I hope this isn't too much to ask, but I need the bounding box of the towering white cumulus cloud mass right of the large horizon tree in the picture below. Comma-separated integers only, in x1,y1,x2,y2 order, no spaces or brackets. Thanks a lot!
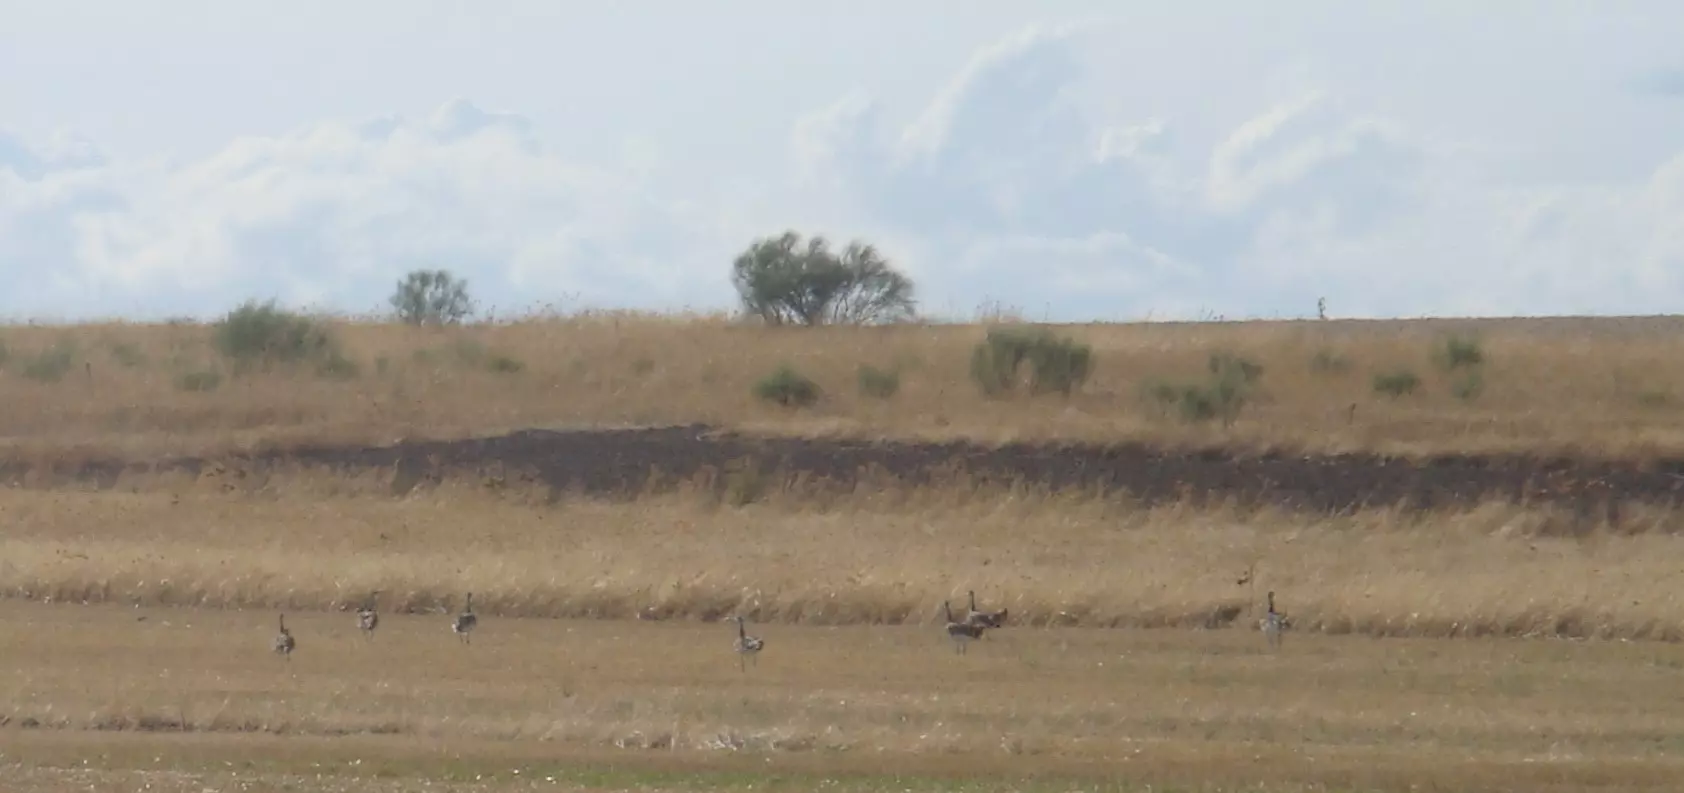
781,27,1684,318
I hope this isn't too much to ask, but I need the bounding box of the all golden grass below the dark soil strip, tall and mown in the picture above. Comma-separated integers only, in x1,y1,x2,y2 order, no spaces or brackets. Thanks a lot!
0,471,1684,793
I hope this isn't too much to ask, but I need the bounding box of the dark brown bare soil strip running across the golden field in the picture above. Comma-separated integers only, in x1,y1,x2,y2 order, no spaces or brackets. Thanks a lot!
0,426,1684,524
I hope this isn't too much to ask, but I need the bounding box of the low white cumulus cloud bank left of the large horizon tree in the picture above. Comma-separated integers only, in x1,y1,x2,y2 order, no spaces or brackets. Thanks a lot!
0,99,751,317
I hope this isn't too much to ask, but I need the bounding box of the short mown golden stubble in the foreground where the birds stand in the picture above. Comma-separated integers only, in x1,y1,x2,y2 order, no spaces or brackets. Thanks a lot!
0,603,1684,793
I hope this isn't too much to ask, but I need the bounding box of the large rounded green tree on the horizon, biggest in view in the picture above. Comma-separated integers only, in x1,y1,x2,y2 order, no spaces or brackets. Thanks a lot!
731,231,916,325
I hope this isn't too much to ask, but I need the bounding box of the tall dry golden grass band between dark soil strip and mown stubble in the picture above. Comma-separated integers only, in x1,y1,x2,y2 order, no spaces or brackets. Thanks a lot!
0,473,1684,641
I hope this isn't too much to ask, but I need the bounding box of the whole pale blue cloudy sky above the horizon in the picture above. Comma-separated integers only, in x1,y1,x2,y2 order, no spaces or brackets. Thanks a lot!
0,0,1684,322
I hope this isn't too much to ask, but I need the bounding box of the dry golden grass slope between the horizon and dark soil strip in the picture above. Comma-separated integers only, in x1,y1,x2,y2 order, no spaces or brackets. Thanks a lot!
0,308,1684,456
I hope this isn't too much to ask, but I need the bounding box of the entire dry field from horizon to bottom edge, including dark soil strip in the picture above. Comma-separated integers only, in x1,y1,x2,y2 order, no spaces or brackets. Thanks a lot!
0,318,1684,793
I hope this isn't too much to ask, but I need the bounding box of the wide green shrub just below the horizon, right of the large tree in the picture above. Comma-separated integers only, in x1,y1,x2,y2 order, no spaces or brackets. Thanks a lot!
970,328,1093,397
